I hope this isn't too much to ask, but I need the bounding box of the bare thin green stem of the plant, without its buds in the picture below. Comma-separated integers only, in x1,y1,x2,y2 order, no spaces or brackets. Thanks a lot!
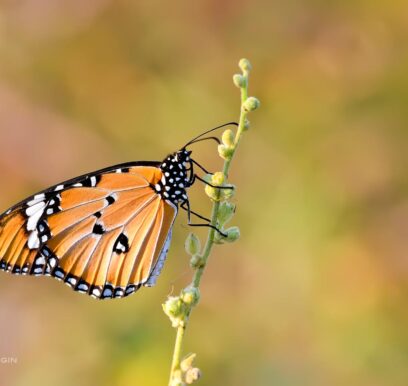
169,61,253,386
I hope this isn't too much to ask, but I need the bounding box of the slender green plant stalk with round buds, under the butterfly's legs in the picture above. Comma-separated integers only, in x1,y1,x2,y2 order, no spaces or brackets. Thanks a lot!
163,59,259,386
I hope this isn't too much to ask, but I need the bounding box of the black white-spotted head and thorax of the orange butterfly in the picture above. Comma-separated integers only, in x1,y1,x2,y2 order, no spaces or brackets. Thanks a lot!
154,149,191,205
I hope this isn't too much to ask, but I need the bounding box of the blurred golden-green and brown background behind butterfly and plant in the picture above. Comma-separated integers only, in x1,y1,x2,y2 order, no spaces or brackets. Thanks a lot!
0,0,408,386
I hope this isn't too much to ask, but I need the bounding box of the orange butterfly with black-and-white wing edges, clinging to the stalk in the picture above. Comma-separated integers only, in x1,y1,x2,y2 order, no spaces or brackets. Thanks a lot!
0,122,237,299
